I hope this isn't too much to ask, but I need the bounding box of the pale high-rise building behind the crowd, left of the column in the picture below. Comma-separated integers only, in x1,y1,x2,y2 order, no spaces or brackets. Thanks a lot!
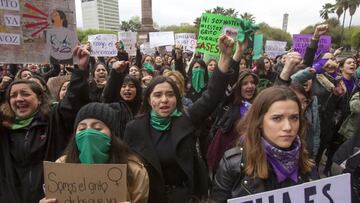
81,0,120,31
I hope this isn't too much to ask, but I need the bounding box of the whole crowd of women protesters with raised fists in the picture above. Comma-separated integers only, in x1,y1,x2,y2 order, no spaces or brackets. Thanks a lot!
0,22,360,203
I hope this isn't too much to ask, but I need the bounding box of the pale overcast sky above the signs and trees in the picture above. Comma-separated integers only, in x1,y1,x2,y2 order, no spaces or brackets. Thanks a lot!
75,0,360,34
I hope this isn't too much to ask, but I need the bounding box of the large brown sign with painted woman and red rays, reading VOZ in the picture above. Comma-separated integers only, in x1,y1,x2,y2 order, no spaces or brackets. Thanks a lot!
0,0,78,64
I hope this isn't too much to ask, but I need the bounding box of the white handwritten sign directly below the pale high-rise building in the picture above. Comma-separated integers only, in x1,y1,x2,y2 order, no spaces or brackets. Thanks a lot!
88,34,118,56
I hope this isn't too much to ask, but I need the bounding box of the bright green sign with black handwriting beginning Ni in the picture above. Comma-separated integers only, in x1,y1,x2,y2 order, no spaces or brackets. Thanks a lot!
196,13,240,55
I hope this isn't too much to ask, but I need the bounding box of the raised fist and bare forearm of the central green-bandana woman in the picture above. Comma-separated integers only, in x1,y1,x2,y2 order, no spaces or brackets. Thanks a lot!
218,35,234,73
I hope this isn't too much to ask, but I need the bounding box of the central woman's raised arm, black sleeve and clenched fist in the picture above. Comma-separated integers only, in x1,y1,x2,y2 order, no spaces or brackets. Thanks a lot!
188,35,234,125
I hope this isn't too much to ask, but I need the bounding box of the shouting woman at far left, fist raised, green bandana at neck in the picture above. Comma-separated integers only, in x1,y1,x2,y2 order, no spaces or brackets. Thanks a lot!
0,46,90,203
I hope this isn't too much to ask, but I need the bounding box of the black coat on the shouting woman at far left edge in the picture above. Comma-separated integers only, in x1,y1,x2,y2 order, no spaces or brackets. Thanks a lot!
0,69,89,203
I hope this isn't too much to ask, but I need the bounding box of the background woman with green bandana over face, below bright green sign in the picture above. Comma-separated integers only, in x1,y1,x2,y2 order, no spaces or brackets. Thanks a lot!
186,59,209,102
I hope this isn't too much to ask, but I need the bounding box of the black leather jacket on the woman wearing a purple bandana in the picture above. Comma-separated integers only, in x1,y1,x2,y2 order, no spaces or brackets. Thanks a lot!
210,147,319,202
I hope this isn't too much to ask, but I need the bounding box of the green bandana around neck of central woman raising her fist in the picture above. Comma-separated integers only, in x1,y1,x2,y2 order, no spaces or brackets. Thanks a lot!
150,109,182,131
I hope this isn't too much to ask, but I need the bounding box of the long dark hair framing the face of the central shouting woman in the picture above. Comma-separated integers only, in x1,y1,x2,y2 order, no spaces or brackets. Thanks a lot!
140,76,183,116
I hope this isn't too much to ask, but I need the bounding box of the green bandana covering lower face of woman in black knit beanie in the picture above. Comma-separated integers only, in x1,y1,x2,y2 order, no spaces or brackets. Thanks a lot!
75,128,111,164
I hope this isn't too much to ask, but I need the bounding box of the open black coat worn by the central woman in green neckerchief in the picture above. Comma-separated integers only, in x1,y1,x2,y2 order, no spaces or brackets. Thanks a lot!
124,70,231,203
